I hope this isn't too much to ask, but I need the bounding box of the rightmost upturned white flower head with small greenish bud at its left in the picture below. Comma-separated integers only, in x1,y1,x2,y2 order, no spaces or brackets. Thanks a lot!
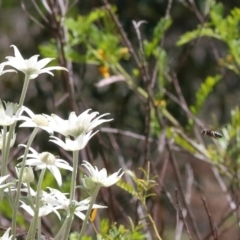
82,160,124,188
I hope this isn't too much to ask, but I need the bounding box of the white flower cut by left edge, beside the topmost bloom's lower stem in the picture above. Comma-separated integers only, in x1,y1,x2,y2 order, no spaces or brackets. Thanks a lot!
0,100,22,126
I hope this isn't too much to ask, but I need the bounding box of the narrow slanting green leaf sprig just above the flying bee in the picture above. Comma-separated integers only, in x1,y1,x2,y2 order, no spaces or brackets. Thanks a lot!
190,75,221,115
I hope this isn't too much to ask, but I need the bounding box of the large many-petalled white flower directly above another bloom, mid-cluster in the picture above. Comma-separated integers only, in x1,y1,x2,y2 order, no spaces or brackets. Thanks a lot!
47,109,112,138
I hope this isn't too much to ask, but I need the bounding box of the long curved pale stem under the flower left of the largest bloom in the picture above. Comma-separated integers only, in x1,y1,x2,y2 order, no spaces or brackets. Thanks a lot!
12,127,38,237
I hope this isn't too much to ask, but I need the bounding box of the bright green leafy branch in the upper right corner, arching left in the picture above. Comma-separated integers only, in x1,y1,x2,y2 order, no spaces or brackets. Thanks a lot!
177,3,240,75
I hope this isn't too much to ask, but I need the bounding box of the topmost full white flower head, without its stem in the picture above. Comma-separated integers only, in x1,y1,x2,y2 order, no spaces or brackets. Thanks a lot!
2,45,68,79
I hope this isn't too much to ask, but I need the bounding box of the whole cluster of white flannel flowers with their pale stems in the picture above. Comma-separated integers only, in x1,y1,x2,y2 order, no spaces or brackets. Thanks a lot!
0,45,124,239
